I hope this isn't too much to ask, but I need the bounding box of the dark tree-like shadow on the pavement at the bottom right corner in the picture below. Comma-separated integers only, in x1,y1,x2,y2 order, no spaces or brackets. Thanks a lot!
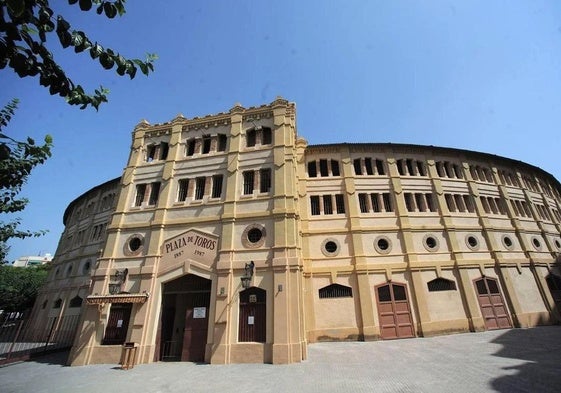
491,326,561,393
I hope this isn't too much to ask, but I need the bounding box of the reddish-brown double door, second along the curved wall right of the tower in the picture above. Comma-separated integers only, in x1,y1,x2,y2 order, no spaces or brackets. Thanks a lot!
474,277,512,330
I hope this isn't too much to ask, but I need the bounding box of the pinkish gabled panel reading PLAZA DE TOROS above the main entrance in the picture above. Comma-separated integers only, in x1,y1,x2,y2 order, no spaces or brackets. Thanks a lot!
162,230,218,266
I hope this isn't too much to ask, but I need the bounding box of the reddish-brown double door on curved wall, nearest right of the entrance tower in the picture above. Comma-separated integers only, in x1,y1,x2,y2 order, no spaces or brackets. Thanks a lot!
375,283,415,340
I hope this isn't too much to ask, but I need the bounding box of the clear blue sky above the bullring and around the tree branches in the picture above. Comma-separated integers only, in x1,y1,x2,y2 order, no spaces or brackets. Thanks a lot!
0,0,561,260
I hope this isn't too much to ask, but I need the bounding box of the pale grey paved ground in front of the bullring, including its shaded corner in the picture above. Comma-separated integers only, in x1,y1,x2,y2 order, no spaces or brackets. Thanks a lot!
0,326,561,393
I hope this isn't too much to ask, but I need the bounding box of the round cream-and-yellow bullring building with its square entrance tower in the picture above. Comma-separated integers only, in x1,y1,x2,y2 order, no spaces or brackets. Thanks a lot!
25,97,561,365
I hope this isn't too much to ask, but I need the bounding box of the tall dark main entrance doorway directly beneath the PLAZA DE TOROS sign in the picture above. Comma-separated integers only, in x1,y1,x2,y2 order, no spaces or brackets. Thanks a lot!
159,274,212,362
